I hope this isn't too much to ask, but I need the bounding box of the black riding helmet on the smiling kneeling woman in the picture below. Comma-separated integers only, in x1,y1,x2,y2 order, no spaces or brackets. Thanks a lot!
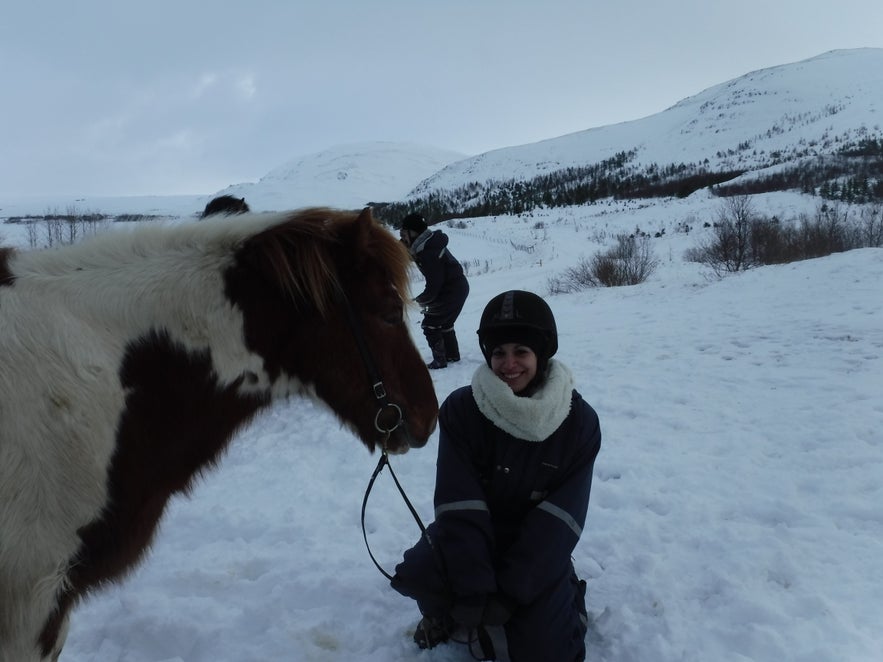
478,290,558,374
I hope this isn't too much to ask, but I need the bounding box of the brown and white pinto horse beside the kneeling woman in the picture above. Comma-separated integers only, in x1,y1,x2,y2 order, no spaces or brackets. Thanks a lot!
0,208,438,662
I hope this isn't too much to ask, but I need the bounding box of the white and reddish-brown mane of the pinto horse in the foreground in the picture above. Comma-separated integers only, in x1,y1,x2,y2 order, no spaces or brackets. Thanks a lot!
0,207,410,316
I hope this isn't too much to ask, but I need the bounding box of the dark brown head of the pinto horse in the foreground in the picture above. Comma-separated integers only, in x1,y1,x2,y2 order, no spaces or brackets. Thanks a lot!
227,209,438,452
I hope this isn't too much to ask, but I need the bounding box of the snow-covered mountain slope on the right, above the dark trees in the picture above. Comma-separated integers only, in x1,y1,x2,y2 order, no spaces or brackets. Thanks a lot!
412,48,883,196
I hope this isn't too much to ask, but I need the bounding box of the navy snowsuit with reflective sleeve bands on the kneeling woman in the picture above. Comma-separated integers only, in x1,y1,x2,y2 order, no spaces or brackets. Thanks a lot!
392,386,601,662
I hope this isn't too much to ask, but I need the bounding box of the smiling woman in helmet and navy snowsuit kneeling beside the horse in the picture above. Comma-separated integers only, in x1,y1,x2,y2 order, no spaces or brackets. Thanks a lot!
391,290,601,662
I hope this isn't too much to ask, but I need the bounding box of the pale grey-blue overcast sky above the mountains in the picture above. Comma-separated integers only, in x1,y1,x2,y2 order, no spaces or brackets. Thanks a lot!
0,0,883,197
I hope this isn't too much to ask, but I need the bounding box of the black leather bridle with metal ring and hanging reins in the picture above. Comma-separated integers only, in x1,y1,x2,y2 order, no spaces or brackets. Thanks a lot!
338,291,435,580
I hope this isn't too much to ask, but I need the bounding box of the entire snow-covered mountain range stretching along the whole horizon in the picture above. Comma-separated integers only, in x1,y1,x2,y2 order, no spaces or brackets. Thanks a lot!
0,48,883,223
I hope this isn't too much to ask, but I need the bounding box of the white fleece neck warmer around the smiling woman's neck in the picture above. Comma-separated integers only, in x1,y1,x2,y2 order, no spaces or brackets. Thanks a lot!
472,359,573,441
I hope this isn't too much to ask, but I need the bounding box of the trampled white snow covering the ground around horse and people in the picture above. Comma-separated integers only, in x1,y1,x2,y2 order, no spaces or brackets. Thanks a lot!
0,194,883,662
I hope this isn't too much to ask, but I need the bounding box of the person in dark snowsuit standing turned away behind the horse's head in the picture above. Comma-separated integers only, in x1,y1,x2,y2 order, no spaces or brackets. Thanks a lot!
399,214,469,370
